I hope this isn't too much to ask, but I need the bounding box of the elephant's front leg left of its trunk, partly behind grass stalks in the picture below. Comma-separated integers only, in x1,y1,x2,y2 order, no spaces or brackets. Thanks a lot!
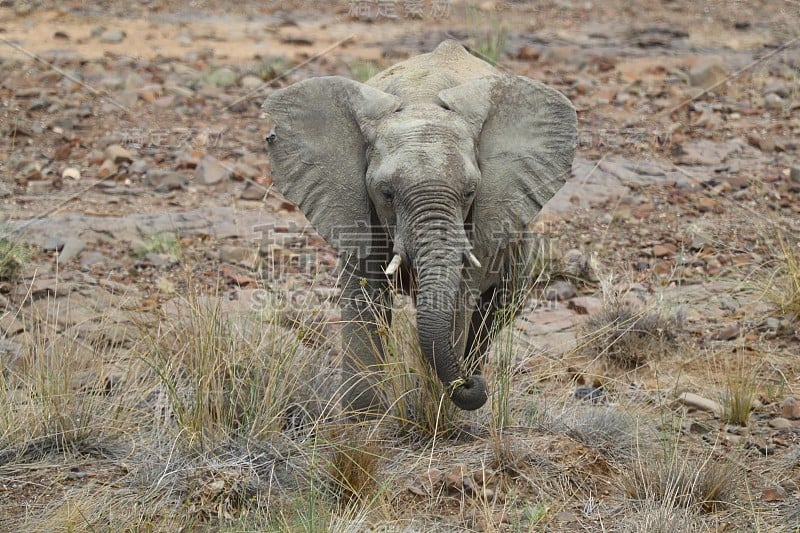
342,264,391,417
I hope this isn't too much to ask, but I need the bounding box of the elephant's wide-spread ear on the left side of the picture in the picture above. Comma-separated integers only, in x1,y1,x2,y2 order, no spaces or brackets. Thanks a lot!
263,76,400,246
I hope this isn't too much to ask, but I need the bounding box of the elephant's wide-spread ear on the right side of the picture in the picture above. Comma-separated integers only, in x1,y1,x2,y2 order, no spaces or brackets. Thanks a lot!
438,76,577,252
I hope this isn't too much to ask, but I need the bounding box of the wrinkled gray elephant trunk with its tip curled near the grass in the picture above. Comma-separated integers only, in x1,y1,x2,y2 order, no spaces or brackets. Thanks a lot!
413,214,487,411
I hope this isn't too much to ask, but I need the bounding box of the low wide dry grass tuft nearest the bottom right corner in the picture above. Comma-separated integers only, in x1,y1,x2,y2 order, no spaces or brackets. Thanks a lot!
620,445,740,512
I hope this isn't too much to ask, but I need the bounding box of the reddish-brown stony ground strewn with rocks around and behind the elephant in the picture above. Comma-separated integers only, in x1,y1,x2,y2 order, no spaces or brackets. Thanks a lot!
0,0,800,530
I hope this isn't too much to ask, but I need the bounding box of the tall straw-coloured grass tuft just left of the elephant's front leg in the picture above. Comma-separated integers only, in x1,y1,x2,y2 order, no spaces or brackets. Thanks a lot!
142,294,331,453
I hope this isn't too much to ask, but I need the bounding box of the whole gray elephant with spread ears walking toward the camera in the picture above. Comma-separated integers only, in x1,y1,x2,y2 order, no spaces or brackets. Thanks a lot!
264,41,577,414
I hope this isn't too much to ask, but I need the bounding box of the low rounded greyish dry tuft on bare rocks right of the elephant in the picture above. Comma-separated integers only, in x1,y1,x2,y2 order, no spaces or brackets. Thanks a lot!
581,298,678,368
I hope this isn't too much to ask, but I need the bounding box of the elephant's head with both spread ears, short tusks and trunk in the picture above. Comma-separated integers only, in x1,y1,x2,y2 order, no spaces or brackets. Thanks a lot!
264,40,576,409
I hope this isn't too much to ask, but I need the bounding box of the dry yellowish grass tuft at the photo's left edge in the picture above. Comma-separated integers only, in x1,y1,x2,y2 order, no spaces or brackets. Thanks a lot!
0,310,132,465
